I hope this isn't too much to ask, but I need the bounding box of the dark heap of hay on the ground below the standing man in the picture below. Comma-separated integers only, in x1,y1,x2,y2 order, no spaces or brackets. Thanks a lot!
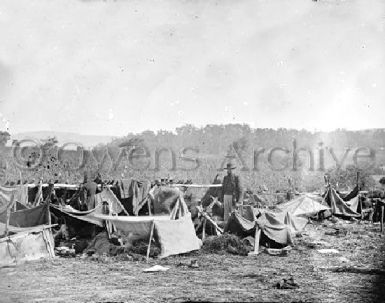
202,233,252,256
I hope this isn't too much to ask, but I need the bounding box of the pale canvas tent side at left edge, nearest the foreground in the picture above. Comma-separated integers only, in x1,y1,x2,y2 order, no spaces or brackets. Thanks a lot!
0,227,55,267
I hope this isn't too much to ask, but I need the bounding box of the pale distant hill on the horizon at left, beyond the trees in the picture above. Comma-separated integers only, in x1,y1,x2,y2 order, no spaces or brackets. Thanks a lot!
9,131,116,147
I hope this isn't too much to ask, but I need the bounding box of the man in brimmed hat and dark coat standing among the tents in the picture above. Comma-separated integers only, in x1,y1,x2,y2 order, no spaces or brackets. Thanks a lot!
222,163,243,223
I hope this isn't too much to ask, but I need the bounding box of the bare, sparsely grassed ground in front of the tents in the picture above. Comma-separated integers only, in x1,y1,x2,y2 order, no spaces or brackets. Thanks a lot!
0,222,385,302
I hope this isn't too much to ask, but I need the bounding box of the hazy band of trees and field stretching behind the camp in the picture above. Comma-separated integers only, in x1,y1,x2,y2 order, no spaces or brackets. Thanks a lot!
0,124,385,191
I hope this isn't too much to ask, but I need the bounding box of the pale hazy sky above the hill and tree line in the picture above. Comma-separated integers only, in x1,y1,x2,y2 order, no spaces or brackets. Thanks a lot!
0,0,385,135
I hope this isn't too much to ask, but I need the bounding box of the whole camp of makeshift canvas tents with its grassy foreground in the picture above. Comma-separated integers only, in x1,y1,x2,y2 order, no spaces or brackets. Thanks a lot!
0,179,385,302
